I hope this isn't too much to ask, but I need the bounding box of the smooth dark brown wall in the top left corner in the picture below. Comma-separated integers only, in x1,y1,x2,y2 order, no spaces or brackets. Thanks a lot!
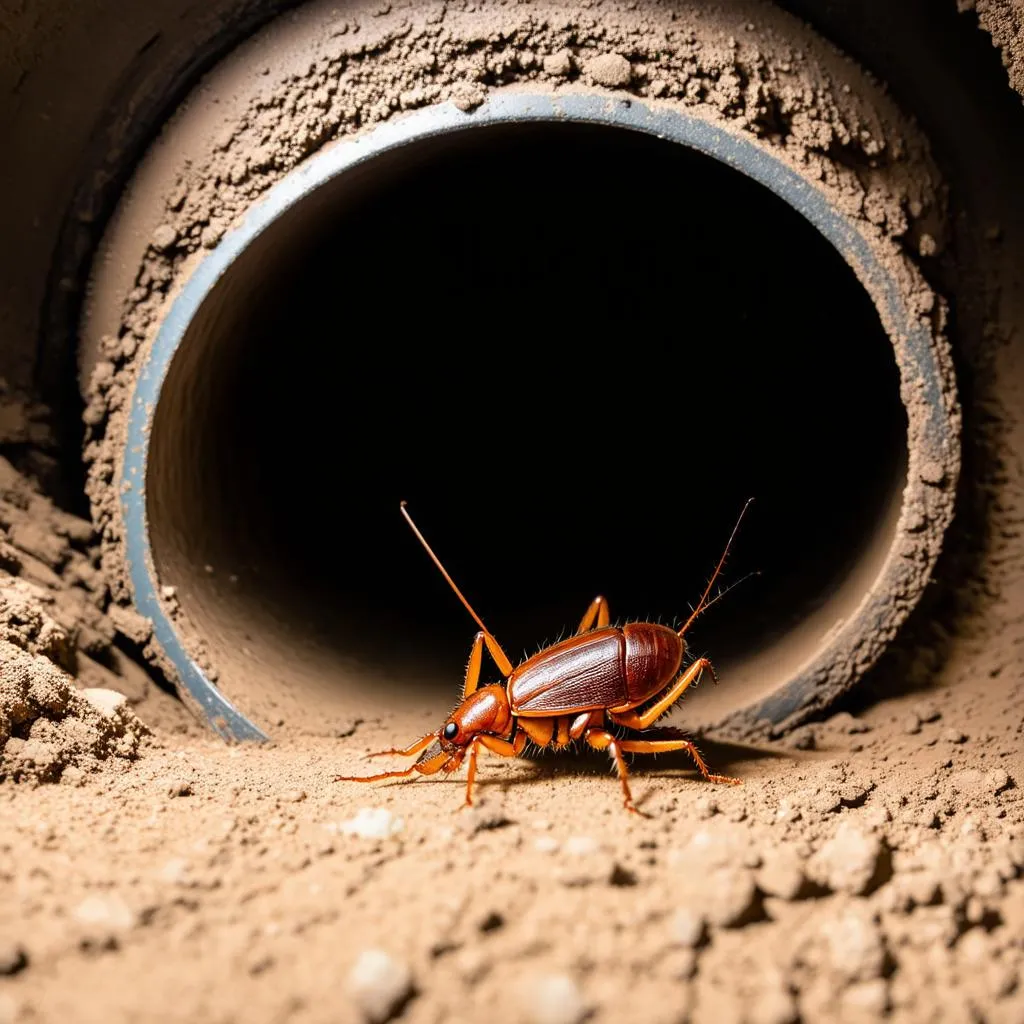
0,0,294,387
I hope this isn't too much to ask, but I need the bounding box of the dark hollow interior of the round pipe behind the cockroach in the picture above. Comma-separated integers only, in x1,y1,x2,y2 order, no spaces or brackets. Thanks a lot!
146,123,907,731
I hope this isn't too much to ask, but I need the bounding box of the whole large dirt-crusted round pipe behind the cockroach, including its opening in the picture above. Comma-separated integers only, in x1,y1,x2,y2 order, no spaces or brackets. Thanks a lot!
74,0,959,738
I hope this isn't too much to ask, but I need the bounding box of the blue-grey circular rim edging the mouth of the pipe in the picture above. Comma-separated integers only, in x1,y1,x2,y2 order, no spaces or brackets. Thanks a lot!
121,92,958,740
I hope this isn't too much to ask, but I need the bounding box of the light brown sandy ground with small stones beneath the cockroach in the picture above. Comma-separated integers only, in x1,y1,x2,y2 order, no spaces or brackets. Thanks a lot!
0,622,1024,1024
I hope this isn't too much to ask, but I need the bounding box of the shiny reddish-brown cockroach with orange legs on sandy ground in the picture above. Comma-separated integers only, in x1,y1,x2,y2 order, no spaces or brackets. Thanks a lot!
335,501,751,813
